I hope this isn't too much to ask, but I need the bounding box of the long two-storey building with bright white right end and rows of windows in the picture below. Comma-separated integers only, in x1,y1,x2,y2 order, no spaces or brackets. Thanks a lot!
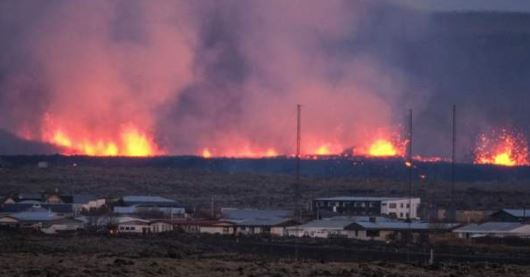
312,196,421,219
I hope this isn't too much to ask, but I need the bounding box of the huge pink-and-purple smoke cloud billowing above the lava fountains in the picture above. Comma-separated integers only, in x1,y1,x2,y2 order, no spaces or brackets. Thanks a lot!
0,0,530,159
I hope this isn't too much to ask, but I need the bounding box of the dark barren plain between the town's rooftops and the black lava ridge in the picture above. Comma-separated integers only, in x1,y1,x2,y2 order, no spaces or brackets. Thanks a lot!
0,166,530,209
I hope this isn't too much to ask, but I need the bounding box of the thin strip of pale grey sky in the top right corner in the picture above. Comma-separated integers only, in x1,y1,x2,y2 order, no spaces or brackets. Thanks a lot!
397,0,530,12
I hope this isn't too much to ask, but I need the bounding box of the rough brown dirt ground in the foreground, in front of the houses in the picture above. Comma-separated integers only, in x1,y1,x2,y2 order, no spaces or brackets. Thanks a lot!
0,233,530,277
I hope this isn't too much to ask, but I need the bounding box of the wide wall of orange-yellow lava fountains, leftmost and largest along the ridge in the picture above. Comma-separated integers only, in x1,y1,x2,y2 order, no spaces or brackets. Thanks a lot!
45,126,163,157
